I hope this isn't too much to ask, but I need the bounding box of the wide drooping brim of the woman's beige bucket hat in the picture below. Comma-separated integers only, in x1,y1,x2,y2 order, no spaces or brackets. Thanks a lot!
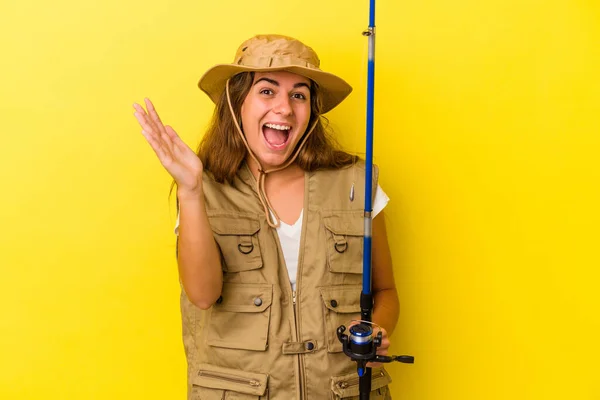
198,64,352,114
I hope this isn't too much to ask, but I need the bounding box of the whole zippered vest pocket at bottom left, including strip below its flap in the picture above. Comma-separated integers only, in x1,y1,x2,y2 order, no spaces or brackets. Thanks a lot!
192,364,268,400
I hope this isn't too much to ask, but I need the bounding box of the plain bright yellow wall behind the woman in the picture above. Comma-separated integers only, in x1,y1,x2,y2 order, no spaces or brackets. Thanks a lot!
0,0,600,400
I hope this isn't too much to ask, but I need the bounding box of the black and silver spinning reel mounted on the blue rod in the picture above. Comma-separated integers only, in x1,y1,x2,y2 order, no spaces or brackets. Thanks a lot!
337,321,415,377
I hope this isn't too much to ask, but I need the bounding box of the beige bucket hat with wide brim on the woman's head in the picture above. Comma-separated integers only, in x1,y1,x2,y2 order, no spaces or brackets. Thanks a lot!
198,35,352,113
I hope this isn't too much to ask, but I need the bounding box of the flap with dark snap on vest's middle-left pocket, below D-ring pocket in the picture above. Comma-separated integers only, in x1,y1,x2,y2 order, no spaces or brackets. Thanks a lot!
213,283,273,313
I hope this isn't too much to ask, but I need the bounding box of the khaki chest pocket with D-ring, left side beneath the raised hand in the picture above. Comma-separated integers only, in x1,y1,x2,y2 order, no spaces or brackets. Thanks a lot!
209,216,262,272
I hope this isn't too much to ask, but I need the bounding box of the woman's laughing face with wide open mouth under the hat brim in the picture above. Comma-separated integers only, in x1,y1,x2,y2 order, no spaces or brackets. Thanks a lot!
241,71,310,169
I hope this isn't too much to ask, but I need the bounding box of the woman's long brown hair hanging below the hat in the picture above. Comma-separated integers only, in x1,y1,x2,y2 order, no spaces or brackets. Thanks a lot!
197,72,357,183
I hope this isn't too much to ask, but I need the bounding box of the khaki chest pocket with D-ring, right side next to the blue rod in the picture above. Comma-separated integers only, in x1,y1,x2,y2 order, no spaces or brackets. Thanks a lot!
323,216,364,274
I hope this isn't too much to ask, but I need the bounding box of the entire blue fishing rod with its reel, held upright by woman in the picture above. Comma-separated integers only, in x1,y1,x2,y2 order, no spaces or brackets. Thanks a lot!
337,0,414,400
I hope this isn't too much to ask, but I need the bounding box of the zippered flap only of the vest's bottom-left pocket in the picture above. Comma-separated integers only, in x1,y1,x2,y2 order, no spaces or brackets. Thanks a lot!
192,364,269,396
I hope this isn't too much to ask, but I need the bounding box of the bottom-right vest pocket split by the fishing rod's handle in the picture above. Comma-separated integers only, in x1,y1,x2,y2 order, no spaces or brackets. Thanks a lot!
331,368,392,400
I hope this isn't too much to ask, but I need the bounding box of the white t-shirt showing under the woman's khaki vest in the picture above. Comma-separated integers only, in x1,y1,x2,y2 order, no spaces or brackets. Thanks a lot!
175,185,390,290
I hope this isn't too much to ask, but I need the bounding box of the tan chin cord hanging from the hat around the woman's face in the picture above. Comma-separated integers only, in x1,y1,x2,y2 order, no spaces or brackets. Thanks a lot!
225,79,319,228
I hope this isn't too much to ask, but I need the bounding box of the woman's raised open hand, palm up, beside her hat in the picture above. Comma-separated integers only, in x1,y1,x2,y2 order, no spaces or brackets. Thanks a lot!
133,99,202,194
